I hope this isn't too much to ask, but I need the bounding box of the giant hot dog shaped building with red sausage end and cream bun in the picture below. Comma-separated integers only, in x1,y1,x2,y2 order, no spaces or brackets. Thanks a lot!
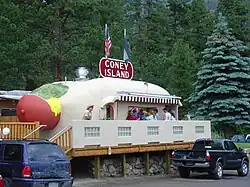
17,78,181,136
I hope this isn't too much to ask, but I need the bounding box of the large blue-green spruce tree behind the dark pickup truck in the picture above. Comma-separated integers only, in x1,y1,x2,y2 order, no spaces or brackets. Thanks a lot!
189,14,250,134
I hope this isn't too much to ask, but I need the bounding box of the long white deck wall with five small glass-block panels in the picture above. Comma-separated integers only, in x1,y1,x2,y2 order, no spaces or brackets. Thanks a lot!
70,120,211,148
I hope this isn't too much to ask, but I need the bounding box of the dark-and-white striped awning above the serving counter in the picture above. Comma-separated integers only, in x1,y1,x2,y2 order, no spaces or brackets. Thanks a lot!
118,92,181,105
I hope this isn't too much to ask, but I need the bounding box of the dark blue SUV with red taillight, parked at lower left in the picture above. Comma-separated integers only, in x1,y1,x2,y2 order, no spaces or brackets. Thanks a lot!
0,140,73,187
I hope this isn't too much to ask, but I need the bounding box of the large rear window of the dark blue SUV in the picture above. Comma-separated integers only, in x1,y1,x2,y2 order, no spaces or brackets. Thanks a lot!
27,143,67,161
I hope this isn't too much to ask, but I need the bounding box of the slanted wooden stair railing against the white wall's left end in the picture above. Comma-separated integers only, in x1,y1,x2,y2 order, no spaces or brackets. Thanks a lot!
49,126,72,154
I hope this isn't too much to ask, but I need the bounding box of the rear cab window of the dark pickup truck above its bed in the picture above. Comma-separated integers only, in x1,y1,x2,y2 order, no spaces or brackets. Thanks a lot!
193,140,223,150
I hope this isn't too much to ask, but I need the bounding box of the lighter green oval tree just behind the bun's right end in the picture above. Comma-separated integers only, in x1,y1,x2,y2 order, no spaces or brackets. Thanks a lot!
165,40,198,118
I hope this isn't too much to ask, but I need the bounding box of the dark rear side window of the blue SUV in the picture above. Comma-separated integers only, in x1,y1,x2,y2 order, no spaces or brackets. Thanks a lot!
4,144,22,161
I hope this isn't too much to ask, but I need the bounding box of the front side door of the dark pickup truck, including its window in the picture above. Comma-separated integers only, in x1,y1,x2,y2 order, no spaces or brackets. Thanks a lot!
225,141,240,169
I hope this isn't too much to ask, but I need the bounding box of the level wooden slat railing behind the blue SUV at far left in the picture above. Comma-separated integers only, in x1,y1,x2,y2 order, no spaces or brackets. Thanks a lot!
0,122,40,139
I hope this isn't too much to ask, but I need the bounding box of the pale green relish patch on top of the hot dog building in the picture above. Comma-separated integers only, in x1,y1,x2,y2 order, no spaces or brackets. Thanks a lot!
30,83,69,99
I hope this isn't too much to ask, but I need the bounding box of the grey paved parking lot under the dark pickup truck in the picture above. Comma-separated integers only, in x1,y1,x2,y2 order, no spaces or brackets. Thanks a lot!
74,172,250,187
